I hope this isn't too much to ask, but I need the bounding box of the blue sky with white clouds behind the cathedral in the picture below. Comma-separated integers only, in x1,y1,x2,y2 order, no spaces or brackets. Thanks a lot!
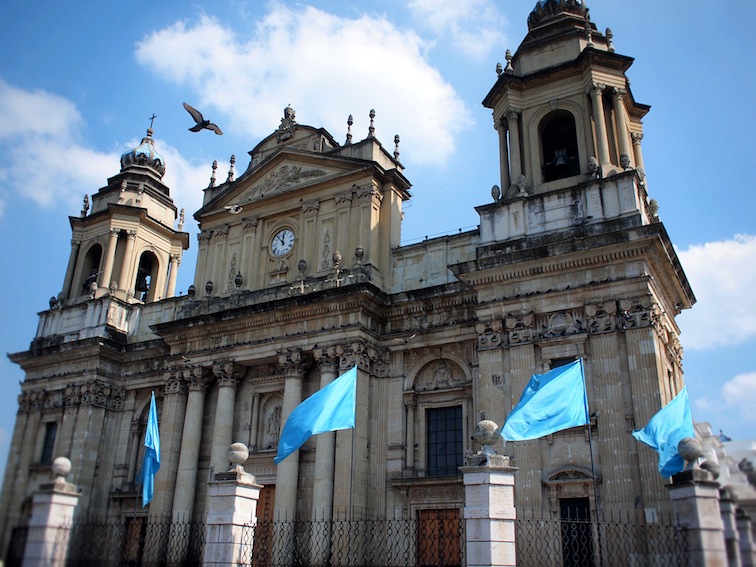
0,0,756,480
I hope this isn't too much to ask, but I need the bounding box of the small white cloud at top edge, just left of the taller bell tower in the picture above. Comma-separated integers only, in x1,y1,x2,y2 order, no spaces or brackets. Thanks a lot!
409,0,506,59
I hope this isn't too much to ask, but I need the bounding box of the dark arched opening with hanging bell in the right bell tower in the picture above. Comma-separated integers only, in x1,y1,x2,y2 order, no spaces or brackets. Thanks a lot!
540,110,580,182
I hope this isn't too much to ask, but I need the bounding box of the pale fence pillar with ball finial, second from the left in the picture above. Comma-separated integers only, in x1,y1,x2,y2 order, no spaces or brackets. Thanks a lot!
203,443,262,567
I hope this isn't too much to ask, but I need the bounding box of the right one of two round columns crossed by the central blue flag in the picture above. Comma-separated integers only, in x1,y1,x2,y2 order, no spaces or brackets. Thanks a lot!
312,347,338,520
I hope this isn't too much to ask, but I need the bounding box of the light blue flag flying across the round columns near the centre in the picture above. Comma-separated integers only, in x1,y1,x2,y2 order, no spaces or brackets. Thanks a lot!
273,366,357,464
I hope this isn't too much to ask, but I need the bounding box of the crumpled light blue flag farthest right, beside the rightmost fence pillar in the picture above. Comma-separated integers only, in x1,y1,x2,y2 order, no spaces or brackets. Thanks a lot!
633,386,696,478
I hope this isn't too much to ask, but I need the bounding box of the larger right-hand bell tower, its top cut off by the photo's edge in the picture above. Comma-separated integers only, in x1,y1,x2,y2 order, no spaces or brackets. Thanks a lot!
483,0,649,198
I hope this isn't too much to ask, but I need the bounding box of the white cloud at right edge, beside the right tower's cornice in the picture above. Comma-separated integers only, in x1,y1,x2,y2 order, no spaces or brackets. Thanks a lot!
678,234,756,350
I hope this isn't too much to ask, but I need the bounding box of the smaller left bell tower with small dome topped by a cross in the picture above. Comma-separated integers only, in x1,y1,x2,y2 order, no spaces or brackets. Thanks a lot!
57,128,189,304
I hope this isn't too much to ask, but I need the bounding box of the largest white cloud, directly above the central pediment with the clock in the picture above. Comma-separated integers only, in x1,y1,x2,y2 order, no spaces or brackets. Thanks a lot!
136,4,473,165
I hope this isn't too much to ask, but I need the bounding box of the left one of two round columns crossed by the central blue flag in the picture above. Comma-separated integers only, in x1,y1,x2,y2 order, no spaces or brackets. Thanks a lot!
274,350,304,520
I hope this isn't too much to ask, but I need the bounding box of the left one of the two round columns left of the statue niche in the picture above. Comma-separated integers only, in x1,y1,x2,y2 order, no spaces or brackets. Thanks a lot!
173,368,205,522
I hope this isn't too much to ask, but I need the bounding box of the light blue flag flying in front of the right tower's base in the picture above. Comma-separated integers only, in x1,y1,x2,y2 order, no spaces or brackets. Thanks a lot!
501,359,588,441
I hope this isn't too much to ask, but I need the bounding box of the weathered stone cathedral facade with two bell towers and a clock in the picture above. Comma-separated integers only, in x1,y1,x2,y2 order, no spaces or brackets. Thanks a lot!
0,0,695,556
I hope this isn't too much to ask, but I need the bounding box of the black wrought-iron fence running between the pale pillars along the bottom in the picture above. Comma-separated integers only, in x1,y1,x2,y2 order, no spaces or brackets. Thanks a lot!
7,510,689,567
